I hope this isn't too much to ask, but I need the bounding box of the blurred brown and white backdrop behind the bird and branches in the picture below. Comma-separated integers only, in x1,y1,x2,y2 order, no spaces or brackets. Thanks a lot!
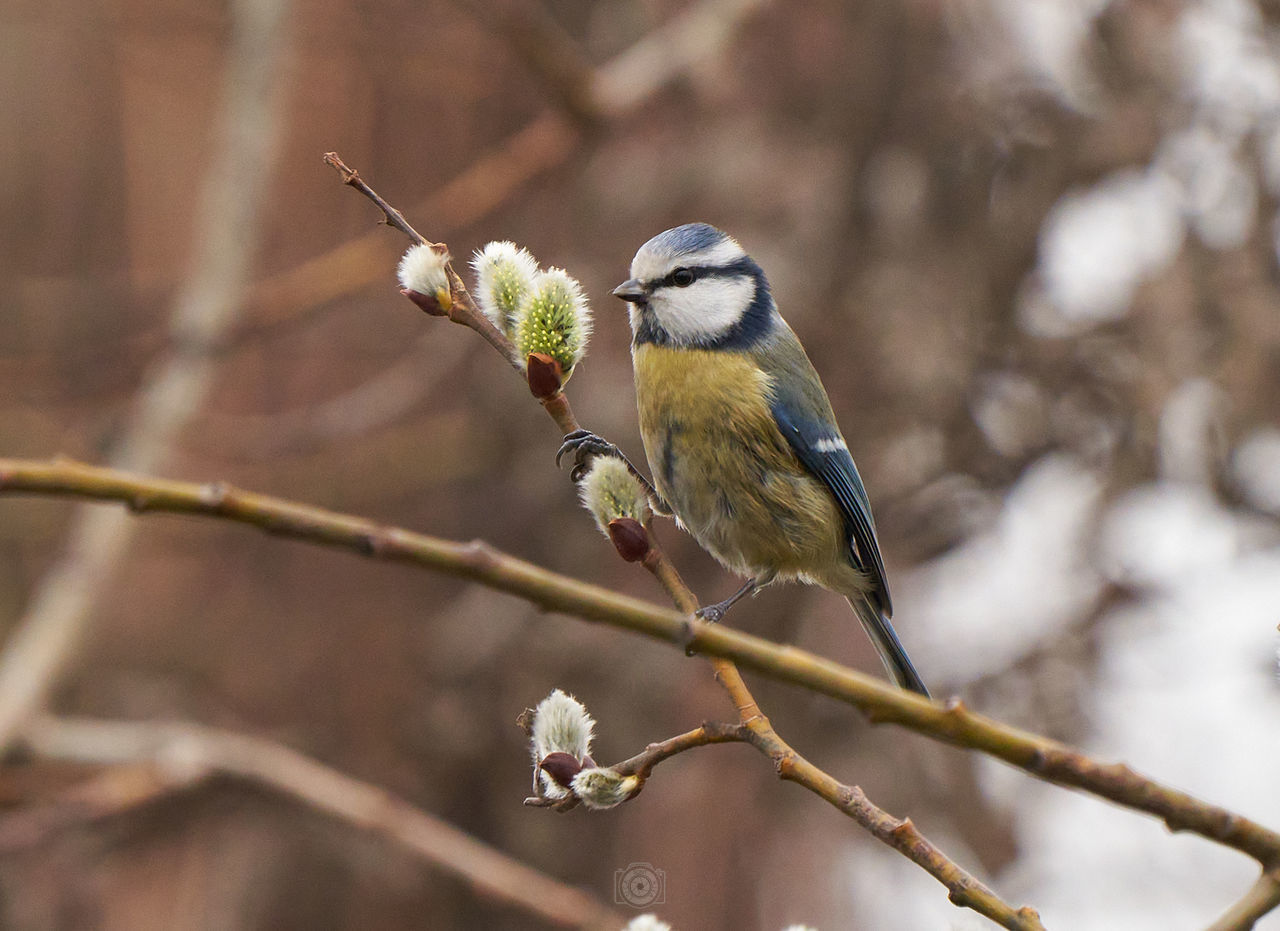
0,0,1280,930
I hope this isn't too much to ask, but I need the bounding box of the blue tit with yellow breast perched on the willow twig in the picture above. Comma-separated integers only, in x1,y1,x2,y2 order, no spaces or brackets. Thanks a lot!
557,223,929,697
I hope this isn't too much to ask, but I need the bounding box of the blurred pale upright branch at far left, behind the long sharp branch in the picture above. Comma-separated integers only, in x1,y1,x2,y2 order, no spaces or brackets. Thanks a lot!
0,0,289,752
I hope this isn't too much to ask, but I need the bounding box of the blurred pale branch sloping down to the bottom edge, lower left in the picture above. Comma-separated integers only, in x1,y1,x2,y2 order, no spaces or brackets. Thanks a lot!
23,717,625,928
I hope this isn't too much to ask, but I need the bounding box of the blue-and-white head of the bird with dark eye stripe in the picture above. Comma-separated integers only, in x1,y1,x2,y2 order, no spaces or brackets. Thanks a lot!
613,223,777,348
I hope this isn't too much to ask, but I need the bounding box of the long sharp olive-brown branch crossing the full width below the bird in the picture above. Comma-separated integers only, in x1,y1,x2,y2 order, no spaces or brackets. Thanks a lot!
10,460,1280,911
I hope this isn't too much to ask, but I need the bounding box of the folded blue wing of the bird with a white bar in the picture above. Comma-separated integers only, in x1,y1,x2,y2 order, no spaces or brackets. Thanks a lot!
772,396,893,617
